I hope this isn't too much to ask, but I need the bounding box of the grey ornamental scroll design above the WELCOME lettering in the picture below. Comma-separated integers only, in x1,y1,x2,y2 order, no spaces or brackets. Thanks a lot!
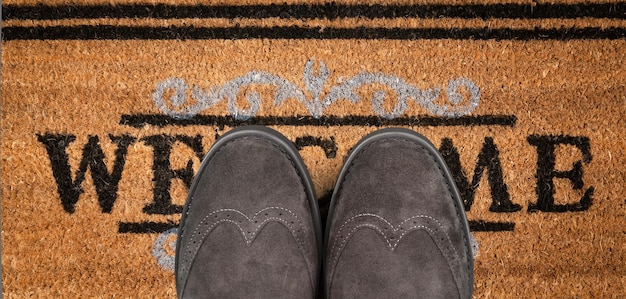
152,60,480,120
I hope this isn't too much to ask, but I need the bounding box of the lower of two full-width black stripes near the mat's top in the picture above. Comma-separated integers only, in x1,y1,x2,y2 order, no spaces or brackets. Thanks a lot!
2,25,626,40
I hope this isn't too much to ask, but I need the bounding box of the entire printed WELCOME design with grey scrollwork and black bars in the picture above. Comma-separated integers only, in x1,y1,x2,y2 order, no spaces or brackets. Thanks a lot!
37,60,594,269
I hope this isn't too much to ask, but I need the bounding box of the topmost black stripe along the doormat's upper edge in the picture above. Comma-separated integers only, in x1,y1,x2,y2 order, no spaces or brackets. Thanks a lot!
2,2,626,20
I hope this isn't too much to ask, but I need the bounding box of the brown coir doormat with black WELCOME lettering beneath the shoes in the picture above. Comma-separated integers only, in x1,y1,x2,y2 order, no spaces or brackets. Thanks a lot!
1,0,626,298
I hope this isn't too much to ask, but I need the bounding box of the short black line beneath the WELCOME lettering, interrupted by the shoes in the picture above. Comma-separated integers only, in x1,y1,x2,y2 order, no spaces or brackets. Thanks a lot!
118,220,515,234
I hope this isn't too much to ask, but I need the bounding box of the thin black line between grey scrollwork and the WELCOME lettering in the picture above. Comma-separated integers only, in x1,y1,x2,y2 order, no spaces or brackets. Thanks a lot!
120,114,517,129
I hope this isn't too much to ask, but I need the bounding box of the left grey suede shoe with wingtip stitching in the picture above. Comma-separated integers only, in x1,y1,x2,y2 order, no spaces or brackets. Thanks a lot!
175,126,322,298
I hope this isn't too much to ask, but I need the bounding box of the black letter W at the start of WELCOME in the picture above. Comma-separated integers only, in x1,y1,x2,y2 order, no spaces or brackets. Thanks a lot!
37,134,135,214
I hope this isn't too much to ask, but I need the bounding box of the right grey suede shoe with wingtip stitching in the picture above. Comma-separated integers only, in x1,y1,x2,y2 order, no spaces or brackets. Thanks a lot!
324,129,474,298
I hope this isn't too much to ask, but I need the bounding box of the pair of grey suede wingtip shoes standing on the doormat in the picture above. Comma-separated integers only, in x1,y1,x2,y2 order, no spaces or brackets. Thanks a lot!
175,126,474,298
